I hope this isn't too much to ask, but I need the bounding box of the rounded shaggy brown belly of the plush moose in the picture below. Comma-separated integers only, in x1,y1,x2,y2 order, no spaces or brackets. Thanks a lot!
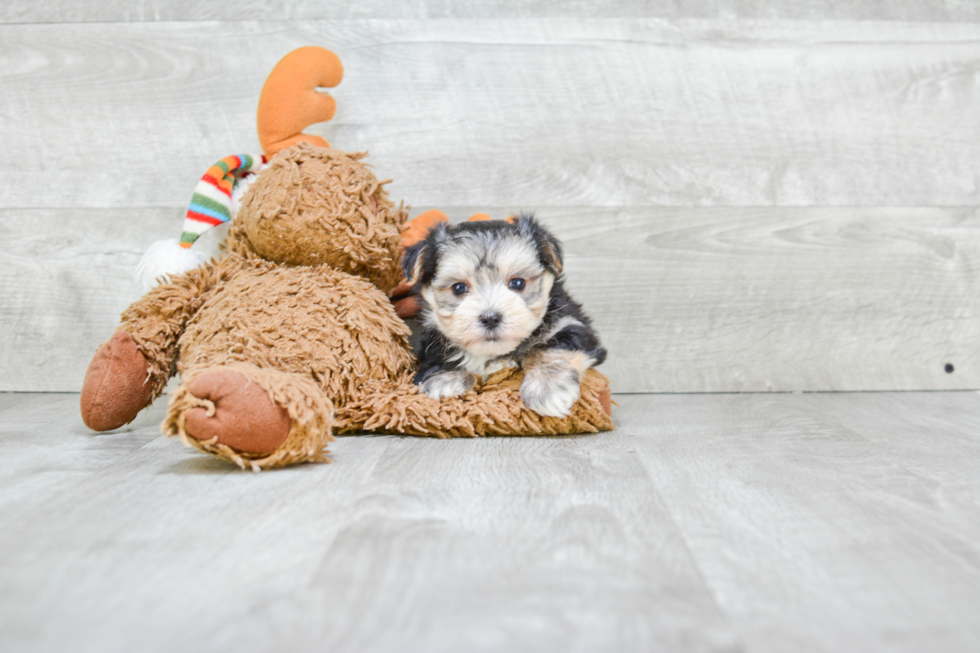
177,254,413,405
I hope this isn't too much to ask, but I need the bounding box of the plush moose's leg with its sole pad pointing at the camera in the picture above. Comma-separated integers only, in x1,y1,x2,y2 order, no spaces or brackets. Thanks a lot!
162,363,333,471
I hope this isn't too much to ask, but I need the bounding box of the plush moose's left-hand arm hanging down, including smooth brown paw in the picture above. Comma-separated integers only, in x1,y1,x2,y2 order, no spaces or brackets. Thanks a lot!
81,257,240,431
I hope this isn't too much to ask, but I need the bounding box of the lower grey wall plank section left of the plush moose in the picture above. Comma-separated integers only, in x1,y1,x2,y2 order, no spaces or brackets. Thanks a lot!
0,209,183,391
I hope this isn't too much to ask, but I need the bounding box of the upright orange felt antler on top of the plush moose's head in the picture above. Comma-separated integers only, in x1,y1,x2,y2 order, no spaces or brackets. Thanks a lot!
257,45,344,157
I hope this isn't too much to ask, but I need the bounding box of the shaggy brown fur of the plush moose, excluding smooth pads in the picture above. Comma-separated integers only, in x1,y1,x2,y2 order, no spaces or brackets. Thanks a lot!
99,144,612,470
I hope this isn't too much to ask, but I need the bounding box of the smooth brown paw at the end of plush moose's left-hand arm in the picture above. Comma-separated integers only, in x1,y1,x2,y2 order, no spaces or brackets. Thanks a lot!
81,331,154,431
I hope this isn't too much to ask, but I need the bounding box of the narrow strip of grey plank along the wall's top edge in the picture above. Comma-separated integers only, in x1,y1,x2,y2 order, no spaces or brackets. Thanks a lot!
0,0,980,23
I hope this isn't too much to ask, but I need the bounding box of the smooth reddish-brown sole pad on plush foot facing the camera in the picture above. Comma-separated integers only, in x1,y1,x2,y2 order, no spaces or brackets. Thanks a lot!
184,370,291,455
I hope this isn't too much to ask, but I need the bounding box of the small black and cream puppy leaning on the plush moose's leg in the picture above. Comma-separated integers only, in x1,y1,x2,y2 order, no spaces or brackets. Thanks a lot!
402,215,606,417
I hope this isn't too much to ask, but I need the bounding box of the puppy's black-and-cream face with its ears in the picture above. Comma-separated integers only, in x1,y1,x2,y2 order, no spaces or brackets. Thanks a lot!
405,218,561,357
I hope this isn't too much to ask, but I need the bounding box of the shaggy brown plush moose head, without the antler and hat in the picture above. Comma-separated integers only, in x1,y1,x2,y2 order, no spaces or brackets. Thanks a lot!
228,143,407,293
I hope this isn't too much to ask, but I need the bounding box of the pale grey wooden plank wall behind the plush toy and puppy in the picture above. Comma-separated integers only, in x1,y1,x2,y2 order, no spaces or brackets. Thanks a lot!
0,0,980,392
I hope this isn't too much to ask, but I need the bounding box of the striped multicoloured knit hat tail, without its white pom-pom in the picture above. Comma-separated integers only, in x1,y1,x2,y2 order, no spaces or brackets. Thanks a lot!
180,154,267,249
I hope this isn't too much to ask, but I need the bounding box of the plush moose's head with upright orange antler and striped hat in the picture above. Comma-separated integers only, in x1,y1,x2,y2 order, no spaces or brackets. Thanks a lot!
136,46,407,293
